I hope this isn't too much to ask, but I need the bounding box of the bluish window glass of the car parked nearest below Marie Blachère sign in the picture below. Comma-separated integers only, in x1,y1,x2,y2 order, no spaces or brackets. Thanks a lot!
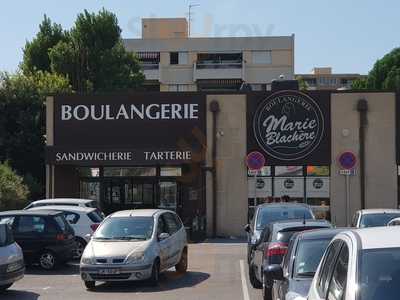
256,207,313,230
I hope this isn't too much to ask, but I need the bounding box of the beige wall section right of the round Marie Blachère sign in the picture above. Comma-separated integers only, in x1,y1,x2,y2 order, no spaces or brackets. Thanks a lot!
331,93,397,225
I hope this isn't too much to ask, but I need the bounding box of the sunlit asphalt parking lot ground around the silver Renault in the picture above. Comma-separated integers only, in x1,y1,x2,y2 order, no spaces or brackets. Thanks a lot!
1,240,261,300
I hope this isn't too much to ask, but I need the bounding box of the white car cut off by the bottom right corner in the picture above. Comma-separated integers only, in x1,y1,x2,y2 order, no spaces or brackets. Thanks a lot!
307,226,400,300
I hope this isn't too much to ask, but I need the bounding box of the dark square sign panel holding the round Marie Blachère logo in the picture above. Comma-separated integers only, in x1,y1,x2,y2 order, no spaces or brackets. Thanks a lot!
248,91,331,165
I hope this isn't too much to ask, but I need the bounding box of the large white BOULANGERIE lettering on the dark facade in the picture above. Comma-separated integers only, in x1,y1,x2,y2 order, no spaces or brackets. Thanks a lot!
60,103,199,121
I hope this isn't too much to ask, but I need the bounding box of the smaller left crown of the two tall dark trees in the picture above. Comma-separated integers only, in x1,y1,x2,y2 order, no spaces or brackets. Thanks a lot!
21,15,67,73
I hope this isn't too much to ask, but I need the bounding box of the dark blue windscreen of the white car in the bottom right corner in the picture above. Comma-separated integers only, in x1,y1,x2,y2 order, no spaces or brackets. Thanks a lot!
358,248,400,300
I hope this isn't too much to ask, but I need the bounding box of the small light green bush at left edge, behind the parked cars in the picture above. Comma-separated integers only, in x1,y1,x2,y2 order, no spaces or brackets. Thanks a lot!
0,162,29,210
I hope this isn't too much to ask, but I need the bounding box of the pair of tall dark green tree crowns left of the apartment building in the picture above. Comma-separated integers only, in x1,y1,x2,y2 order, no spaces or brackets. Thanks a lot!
22,9,144,93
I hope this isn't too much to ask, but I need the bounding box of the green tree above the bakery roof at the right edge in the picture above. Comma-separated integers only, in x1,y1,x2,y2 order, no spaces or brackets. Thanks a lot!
353,48,400,91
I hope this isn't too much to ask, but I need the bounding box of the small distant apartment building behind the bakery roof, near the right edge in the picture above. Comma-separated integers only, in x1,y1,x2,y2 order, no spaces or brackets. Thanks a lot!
295,67,366,90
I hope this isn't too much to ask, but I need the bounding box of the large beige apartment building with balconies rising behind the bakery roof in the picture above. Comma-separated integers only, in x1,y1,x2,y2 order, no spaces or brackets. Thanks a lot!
124,18,294,92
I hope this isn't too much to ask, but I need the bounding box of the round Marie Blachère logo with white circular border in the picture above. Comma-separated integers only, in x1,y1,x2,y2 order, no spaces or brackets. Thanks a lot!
253,91,324,161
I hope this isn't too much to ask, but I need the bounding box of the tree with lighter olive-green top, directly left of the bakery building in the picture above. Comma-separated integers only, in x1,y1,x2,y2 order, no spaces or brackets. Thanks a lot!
0,71,72,198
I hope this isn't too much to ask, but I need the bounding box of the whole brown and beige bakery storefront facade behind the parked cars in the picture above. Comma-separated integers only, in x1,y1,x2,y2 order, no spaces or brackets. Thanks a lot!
46,90,400,238
